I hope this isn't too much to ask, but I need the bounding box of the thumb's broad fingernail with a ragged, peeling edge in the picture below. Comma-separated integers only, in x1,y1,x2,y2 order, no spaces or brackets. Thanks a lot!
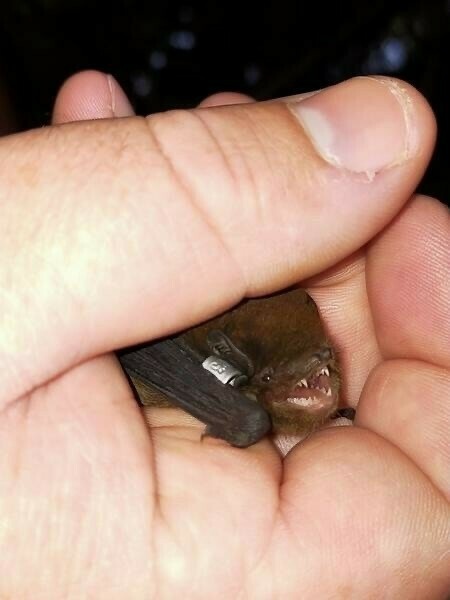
288,77,413,179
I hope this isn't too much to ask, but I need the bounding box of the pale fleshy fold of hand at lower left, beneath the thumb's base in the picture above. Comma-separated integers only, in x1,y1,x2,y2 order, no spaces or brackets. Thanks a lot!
0,357,156,598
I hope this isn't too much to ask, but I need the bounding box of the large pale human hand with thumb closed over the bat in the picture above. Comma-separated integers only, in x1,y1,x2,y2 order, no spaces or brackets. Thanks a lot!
0,72,450,599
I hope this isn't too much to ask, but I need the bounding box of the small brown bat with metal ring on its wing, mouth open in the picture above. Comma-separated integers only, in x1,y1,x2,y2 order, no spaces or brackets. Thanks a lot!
119,289,349,447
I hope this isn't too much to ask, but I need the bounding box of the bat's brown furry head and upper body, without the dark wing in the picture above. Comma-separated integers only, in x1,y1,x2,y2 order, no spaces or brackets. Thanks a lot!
125,289,339,437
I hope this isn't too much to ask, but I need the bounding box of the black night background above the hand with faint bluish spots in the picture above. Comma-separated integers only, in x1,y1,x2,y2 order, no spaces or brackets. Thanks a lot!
0,0,450,203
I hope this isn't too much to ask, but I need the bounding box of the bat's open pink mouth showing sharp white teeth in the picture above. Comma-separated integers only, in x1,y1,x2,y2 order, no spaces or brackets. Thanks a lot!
286,367,335,410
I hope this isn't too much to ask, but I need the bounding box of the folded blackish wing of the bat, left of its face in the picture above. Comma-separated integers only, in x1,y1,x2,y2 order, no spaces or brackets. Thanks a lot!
119,339,271,448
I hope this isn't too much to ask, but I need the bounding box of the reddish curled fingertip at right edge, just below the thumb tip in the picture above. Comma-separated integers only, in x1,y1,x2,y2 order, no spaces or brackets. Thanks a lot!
367,197,450,367
